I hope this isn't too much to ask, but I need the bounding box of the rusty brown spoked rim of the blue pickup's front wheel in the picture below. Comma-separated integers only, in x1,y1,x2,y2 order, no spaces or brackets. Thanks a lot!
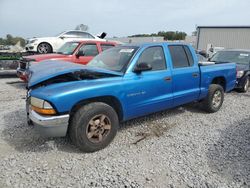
86,114,111,143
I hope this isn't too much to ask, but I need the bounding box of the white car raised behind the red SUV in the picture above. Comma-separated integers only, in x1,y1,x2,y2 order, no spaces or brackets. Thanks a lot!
25,30,106,54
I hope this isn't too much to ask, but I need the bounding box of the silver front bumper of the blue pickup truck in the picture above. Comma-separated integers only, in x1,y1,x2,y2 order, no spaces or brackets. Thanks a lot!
28,109,69,137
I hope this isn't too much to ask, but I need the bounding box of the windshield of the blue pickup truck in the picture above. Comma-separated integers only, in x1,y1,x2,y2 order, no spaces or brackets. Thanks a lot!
87,46,138,72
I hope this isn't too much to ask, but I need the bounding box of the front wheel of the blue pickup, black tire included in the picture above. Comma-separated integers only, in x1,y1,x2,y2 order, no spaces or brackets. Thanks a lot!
69,102,119,152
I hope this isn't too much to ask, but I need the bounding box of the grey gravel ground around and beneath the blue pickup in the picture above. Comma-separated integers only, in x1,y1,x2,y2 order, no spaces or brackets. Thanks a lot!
0,78,250,188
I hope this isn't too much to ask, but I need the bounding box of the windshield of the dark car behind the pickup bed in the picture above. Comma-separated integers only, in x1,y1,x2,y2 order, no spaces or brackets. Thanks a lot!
210,51,250,64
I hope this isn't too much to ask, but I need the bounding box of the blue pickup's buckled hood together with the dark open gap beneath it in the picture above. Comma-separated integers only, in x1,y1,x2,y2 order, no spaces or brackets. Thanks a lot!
28,61,122,89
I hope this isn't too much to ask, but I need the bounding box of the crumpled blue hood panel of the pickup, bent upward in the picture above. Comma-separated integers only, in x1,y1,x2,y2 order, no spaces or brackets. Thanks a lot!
28,60,123,88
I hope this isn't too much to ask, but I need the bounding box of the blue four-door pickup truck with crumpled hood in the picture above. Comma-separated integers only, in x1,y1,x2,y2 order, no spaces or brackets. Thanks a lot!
26,43,236,152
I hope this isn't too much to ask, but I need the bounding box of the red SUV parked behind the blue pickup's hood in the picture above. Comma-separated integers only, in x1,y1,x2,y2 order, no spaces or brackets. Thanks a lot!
17,41,117,81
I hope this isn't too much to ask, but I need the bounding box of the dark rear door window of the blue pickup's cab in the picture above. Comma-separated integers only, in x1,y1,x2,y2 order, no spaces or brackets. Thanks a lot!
169,45,189,68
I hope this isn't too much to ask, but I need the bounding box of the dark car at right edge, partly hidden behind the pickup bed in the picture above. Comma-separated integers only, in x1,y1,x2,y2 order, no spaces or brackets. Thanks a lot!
210,49,250,92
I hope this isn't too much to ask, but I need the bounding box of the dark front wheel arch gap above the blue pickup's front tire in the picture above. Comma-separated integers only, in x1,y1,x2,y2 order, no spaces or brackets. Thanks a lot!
69,95,123,121
